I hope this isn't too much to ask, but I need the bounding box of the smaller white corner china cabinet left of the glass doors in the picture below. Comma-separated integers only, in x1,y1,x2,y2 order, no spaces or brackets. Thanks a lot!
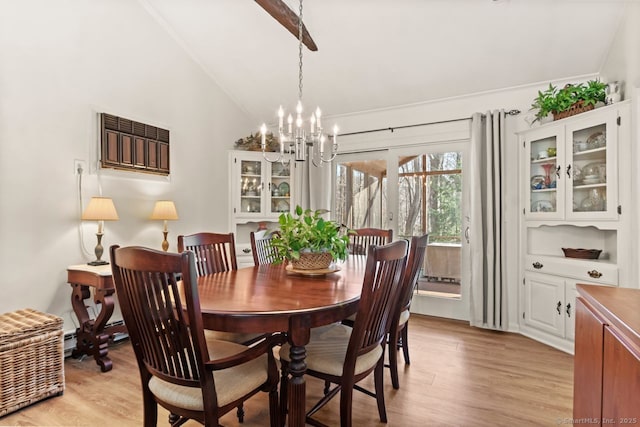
229,150,297,267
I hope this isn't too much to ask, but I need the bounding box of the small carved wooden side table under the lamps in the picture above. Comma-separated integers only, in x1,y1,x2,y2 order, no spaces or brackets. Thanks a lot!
67,264,127,372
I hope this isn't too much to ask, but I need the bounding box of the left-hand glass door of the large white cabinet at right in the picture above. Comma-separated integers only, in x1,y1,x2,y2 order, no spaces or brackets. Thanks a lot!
525,126,564,219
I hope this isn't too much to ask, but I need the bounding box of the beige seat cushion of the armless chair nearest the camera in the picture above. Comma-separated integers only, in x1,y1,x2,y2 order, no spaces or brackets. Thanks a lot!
280,323,382,376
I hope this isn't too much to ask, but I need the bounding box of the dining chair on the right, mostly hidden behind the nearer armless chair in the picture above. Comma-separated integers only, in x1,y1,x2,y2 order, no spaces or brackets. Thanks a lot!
388,234,429,390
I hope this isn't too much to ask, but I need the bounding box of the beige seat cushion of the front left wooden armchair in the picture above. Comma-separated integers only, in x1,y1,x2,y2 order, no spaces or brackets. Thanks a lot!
149,339,267,411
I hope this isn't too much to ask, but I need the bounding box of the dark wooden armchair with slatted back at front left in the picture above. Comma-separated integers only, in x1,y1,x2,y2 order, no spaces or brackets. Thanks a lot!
110,245,279,426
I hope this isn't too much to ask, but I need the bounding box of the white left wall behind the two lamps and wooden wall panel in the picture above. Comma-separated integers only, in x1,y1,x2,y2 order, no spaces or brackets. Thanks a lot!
0,0,253,331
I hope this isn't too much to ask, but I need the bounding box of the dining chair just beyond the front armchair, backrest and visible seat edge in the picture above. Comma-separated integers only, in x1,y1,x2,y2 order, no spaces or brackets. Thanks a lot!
178,232,264,345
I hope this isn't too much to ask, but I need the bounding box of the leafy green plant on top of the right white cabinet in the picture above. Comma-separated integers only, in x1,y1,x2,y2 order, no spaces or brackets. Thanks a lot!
531,80,607,121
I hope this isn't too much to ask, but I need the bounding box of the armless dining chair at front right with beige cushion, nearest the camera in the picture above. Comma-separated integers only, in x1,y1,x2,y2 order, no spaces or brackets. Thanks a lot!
280,240,407,426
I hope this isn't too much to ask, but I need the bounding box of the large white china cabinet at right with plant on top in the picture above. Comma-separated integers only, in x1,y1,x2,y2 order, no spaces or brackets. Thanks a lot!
519,102,631,353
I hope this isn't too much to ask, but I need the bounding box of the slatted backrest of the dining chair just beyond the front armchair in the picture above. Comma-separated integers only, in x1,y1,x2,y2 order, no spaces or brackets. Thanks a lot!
178,232,238,276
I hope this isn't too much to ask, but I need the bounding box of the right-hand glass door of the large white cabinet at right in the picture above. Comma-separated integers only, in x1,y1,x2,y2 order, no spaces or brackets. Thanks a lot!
567,116,617,218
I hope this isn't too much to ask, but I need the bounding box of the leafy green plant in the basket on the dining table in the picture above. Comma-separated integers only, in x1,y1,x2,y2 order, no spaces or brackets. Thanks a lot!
271,206,349,261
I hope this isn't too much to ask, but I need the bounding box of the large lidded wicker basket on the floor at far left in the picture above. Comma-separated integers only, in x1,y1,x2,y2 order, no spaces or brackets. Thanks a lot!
0,309,64,416
